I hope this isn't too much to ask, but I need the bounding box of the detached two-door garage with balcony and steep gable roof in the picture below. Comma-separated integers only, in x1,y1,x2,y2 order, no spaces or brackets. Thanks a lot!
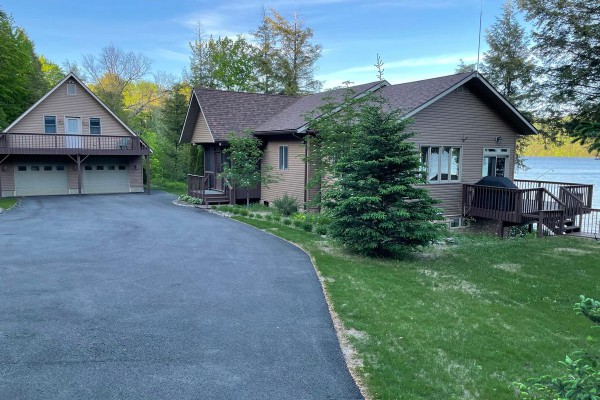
0,73,151,197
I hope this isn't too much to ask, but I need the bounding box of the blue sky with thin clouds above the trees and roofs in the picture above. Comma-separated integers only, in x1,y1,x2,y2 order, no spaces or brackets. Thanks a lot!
0,0,504,87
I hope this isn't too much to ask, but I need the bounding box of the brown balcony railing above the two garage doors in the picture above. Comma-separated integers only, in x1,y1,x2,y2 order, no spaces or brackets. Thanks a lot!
0,133,150,155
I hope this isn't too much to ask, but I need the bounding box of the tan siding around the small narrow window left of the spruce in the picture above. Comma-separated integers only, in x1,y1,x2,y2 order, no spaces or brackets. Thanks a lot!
261,140,305,204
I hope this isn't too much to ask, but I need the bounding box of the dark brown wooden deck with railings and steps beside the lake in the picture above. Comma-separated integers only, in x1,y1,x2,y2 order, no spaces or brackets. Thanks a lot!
463,180,600,238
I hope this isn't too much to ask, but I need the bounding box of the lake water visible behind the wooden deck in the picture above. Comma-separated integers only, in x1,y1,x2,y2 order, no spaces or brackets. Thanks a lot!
515,157,600,208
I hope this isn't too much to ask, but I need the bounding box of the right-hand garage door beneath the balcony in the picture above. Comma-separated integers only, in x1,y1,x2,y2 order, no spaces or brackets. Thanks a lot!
83,163,129,194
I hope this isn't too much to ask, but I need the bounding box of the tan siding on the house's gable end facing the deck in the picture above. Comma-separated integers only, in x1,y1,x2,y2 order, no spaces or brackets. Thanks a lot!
410,91,517,216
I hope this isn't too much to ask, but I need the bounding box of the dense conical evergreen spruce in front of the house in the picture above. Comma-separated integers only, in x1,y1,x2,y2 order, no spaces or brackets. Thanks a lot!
324,98,442,257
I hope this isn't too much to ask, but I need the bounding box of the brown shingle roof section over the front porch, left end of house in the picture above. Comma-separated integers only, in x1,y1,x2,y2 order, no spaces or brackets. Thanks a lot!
194,89,298,141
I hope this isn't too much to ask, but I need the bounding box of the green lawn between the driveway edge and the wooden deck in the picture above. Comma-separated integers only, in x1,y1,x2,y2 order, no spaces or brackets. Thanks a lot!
231,217,600,400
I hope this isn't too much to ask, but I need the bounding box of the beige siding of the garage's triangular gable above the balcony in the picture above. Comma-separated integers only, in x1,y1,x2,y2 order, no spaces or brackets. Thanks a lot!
9,82,131,136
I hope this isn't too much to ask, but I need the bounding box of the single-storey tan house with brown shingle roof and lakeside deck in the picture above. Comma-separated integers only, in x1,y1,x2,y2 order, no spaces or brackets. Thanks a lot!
181,72,592,238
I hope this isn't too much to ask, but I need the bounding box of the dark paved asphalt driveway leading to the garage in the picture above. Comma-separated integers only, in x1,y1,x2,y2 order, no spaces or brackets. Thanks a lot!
0,193,361,400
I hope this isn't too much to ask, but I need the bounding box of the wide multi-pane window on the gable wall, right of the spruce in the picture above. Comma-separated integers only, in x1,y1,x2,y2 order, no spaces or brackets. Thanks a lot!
421,146,462,183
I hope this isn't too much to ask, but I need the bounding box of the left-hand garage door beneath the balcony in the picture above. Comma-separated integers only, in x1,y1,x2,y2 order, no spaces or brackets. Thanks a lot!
15,163,69,196
